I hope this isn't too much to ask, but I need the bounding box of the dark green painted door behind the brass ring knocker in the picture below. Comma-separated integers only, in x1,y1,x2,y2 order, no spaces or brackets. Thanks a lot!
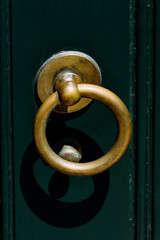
0,0,160,240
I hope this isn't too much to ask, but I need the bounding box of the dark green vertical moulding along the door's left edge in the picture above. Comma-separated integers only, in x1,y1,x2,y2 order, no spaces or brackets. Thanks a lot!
0,0,14,240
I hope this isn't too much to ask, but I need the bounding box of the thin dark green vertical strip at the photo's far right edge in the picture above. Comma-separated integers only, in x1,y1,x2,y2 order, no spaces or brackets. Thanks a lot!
153,0,160,240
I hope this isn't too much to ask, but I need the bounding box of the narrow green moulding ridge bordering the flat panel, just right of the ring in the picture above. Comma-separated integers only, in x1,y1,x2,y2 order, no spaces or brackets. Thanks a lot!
129,0,137,240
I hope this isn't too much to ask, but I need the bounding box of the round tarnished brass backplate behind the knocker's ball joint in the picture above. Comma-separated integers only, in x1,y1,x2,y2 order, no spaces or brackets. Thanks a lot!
36,51,101,113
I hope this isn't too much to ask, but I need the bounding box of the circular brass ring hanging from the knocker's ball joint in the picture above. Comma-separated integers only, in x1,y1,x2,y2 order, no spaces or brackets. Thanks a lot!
34,84,132,176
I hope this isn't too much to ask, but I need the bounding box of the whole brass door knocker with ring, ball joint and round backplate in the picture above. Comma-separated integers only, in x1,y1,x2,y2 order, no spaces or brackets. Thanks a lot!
34,51,132,176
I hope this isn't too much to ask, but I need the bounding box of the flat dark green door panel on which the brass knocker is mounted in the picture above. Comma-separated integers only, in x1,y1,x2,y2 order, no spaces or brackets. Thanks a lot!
12,1,130,240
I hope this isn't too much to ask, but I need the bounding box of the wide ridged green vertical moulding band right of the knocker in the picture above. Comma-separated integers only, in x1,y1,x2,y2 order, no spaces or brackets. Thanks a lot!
129,0,155,240
